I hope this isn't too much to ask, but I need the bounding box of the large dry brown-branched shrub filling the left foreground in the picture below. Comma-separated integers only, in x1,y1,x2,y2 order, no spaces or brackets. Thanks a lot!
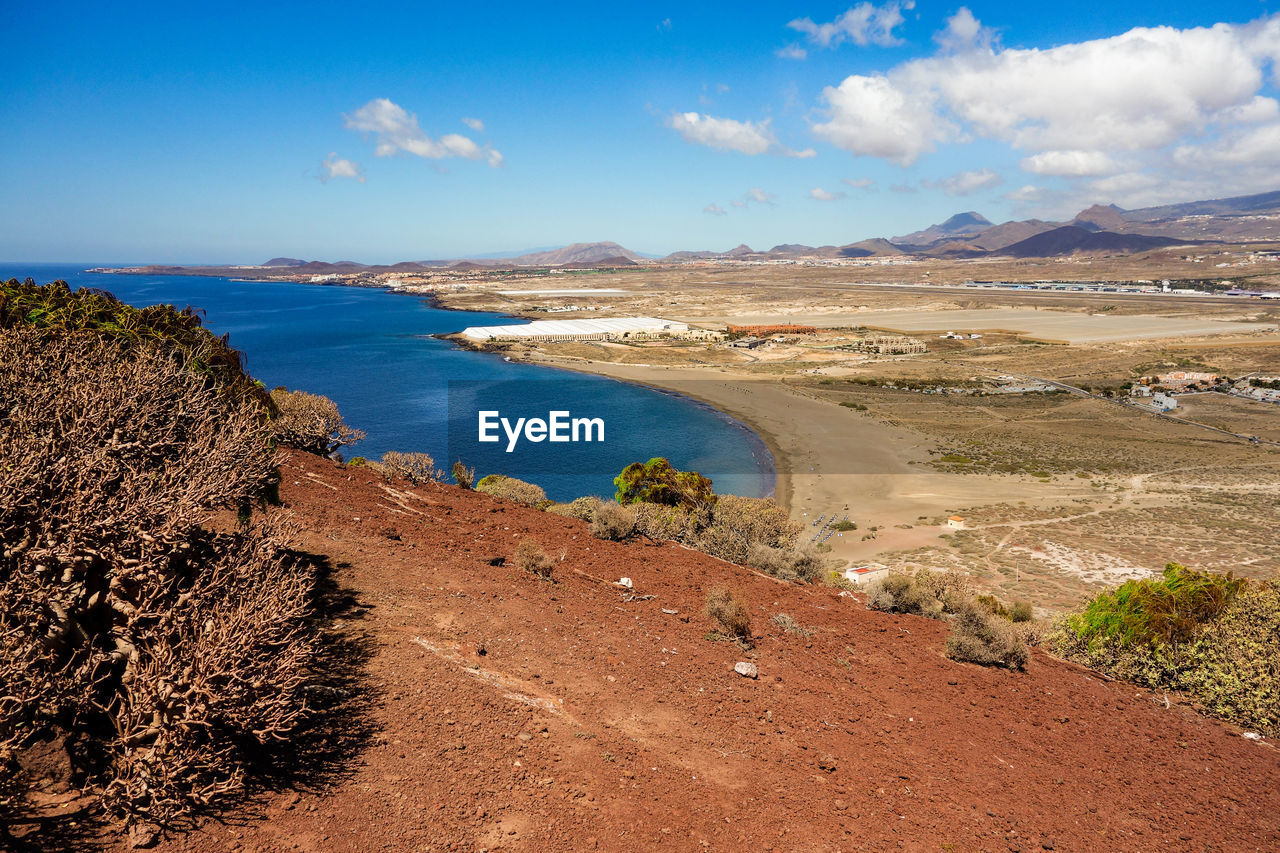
0,329,312,822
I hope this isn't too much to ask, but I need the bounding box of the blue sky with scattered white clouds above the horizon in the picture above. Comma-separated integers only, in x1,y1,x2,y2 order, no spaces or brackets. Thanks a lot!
0,0,1280,263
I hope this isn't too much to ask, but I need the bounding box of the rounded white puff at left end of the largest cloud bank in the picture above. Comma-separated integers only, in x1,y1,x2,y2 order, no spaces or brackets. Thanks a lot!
813,74,956,165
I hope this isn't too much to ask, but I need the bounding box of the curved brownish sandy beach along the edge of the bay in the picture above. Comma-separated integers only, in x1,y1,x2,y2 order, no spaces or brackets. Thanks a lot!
524,357,1088,562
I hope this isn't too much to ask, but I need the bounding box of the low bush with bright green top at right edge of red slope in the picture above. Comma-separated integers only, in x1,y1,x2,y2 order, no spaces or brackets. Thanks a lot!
1051,564,1280,736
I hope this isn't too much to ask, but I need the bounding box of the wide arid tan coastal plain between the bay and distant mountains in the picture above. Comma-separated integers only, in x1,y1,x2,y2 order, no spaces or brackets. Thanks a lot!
433,251,1280,611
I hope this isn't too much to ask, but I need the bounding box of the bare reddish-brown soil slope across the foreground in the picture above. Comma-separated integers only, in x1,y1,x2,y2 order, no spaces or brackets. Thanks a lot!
20,455,1280,850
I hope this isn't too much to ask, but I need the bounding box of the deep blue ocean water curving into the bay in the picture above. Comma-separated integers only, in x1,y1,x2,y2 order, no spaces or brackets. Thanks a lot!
0,264,776,501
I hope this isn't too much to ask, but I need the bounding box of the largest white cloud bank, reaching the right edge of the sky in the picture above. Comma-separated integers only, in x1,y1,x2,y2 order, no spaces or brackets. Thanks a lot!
813,9,1280,206
